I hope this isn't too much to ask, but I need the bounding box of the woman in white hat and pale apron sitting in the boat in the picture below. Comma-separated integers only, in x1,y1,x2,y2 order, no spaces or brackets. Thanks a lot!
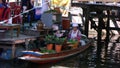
68,23,81,42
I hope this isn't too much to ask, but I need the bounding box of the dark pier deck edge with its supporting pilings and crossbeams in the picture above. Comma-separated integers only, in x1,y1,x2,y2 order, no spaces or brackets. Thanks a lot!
72,3,120,45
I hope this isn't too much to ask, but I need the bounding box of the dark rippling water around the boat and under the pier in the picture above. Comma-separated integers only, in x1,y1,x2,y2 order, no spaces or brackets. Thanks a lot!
0,36,120,68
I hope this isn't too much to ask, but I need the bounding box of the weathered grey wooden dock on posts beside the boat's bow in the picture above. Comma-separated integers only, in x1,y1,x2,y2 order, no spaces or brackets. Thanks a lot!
0,34,37,58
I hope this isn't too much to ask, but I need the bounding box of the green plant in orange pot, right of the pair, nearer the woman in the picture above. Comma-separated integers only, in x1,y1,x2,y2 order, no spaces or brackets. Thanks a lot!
55,37,65,52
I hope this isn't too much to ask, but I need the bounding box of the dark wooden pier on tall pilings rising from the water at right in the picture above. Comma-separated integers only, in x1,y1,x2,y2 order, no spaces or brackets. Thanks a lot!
72,3,120,52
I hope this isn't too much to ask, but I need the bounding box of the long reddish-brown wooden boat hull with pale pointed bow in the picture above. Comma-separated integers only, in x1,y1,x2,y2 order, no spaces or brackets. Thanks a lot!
18,38,92,64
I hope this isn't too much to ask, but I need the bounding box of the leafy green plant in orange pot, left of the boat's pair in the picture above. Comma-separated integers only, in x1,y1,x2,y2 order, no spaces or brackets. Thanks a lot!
45,35,54,50
